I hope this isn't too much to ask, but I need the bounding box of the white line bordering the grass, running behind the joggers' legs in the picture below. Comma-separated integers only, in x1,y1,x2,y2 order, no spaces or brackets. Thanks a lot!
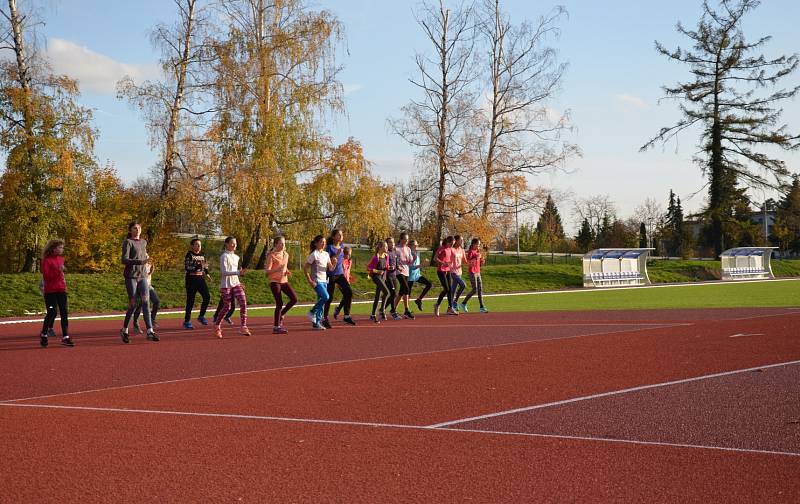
0,278,800,325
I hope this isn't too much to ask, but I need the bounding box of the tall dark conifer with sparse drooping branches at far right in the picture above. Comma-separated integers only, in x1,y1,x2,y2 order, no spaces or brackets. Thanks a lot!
641,0,800,254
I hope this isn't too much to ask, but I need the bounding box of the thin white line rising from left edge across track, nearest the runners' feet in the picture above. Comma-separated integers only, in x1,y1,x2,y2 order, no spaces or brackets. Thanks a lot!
0,324,688,404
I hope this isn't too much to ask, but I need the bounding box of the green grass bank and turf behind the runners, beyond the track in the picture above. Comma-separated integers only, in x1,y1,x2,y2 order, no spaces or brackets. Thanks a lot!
0,257,800,316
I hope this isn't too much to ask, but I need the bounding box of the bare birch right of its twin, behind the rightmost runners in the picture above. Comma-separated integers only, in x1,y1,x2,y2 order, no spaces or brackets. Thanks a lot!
477,0,580,218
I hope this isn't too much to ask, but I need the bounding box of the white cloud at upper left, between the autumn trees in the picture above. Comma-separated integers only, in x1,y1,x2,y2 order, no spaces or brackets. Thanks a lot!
46,38,161,94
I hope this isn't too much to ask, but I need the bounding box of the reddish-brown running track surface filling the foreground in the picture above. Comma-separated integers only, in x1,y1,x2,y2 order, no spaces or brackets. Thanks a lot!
0,310,800,502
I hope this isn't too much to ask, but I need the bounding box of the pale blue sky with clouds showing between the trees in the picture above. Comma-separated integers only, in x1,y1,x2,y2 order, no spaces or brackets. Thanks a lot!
32,0,800,228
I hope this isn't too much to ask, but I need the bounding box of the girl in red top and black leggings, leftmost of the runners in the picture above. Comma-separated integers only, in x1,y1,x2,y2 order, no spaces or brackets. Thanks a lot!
39,240,75,347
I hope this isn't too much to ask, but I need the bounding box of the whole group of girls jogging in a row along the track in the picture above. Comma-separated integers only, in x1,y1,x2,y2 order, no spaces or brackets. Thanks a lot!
40,222,488,347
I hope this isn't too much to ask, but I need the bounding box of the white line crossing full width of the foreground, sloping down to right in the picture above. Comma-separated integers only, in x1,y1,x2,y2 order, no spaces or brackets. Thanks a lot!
0,403,800,457
